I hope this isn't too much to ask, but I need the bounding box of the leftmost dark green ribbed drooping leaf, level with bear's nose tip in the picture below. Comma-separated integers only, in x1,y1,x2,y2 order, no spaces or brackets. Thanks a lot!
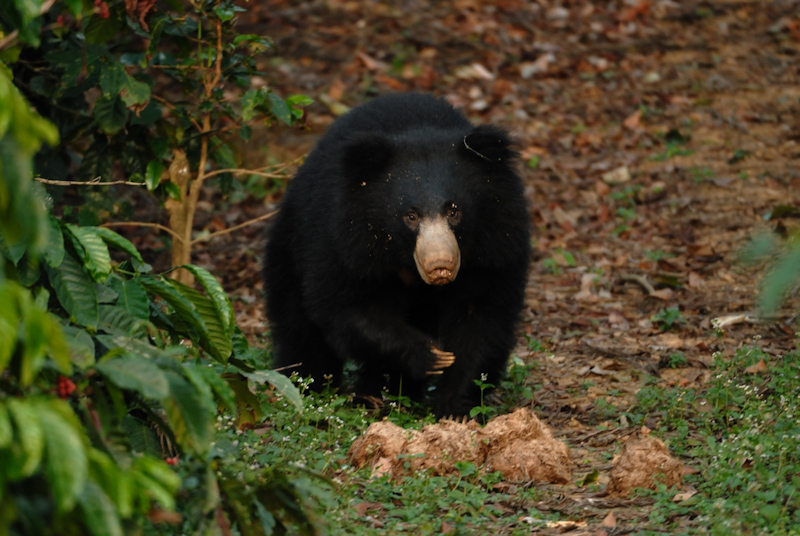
45,249,98,328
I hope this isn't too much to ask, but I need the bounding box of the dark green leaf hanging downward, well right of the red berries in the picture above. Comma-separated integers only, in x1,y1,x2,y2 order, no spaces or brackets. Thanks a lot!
163,371,214,455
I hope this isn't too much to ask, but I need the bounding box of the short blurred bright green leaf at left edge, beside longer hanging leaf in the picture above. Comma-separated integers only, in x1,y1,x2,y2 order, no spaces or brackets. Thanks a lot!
6,398,44,482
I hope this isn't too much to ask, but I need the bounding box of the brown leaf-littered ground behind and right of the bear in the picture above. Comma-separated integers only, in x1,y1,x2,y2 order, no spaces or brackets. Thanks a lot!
195,0,800,532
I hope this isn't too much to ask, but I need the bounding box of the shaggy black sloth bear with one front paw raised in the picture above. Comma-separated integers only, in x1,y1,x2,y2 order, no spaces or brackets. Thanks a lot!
263,93,530,418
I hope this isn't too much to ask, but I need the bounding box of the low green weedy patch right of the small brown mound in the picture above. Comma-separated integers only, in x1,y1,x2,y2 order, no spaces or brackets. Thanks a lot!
627,348,800,535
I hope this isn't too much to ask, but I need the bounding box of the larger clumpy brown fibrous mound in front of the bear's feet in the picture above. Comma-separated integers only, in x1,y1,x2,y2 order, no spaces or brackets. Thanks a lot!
349,409,573,484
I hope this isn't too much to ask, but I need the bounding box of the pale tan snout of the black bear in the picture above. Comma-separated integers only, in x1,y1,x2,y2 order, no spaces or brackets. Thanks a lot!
414,216,461,285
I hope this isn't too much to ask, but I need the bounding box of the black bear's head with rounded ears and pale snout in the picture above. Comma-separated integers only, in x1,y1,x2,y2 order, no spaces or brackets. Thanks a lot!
339,126,527,285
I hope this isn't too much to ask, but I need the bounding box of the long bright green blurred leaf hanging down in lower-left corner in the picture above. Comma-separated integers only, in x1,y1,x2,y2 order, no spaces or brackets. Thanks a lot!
34,398,88,514
